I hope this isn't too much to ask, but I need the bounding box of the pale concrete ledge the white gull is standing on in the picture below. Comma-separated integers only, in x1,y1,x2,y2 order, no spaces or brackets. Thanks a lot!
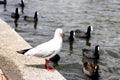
0,19,66,80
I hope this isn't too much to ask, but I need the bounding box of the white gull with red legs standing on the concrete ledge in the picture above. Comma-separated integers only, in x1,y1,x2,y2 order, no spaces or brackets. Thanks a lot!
17,28,63,70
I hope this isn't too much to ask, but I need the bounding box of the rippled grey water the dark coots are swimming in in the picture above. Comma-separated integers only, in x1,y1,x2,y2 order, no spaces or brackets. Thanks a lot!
0,0,120,80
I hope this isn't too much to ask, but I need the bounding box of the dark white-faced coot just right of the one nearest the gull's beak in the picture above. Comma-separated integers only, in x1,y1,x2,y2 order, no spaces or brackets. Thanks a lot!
75,26,93,38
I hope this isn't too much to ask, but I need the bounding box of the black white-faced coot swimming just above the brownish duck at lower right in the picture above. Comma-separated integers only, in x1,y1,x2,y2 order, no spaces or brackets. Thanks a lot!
82,45,99,59
